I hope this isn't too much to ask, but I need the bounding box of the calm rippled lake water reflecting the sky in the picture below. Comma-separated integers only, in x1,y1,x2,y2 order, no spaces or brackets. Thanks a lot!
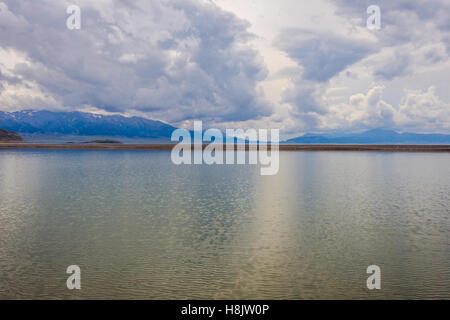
0,150,450,299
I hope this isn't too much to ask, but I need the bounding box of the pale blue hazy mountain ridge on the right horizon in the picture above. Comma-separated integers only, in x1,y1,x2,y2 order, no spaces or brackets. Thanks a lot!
282,129,450,144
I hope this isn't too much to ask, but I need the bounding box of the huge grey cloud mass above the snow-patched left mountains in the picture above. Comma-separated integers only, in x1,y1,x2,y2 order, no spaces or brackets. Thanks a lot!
0,0,272,123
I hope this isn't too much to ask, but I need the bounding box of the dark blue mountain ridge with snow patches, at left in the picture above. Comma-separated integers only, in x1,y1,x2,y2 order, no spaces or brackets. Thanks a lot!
0,111,176,138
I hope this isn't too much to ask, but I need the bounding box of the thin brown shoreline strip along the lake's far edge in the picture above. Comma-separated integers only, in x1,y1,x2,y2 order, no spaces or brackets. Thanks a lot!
0,142,450,152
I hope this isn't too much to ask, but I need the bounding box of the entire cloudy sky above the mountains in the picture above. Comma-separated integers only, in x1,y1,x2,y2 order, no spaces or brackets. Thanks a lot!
0,0,450,137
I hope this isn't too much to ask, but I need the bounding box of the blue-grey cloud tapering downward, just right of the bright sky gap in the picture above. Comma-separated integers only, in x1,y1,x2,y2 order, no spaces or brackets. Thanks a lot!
275,29,374,124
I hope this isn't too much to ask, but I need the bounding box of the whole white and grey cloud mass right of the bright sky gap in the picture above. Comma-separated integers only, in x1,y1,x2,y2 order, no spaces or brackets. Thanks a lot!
275,0,450,132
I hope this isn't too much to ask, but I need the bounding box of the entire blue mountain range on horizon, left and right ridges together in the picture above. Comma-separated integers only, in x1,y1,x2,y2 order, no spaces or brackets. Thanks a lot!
0,111,450,144
